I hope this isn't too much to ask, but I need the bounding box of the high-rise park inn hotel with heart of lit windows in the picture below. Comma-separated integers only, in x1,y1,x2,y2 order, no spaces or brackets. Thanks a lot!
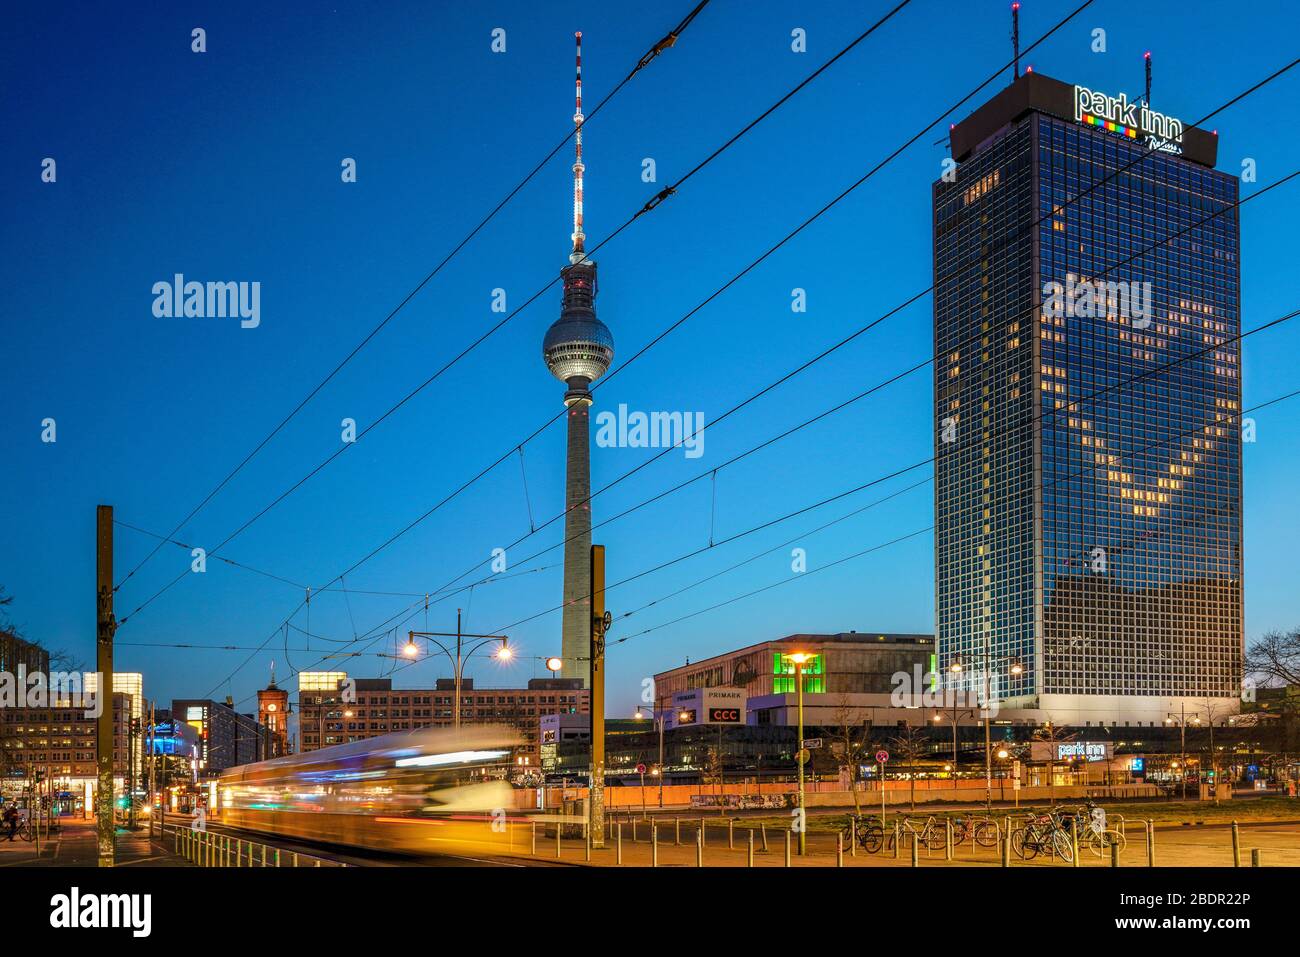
933,73,1243,727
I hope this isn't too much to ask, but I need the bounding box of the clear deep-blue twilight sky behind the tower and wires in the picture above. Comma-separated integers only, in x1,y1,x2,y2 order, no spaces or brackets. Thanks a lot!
0,0,1300,714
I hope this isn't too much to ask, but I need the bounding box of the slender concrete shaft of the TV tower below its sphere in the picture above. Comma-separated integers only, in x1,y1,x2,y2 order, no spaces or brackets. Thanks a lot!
560,390,592,687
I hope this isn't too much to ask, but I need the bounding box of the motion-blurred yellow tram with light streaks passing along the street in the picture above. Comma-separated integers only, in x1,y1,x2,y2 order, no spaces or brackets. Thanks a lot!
216,724,523,853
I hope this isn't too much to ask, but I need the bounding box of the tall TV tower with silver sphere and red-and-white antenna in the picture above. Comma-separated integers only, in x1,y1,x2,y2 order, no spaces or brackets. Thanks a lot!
542,33,614,687
